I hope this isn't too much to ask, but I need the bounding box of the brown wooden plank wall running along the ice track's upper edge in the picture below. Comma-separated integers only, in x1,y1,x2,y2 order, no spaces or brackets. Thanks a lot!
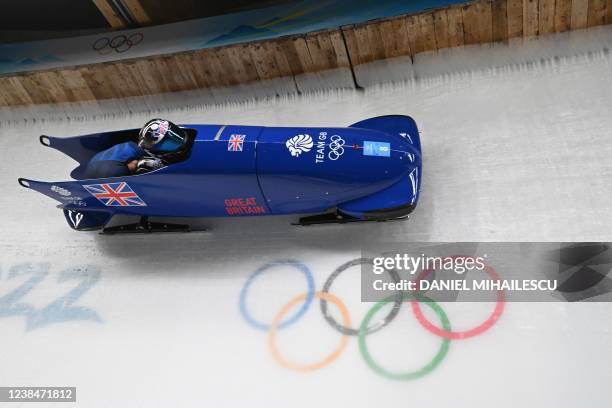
0,0,612,107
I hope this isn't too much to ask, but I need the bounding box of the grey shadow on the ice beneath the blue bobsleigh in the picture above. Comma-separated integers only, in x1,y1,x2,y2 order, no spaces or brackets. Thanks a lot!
89,200,433,273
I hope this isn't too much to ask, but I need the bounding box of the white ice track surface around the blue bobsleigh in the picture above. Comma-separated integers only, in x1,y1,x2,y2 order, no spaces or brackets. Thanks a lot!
0,29,612,408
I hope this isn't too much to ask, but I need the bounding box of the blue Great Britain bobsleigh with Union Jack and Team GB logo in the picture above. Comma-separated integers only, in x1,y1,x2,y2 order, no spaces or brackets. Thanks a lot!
19,115,421,232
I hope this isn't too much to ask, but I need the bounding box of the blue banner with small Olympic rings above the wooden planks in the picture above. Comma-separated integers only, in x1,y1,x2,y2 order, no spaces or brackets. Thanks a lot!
0,0,460,74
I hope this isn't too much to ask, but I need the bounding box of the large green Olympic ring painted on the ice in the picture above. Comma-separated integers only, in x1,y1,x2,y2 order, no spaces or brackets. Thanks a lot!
359,294,451,380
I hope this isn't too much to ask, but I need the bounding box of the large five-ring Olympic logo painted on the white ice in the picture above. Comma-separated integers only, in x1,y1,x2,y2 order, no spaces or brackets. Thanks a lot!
240,256,506,380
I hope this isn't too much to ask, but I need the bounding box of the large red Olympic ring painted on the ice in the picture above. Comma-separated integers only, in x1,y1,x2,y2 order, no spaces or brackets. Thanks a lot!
411,255,506,340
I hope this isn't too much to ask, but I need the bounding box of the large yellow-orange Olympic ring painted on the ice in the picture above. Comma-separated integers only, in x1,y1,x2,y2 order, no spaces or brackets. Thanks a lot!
268,292,351,371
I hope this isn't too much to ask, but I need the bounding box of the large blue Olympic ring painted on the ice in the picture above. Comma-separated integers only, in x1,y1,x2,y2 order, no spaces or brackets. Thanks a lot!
240,259,314,331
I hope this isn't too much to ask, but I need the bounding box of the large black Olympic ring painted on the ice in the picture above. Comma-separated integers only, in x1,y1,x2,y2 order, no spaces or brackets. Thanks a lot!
321,258,402,336
